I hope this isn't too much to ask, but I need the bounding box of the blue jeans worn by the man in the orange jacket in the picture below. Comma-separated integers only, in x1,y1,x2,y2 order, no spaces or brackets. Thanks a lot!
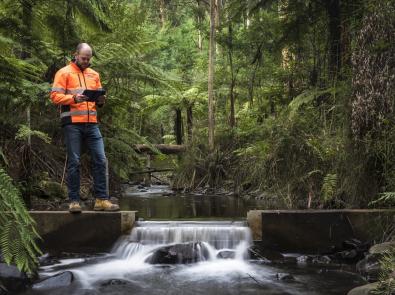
63,123,108,201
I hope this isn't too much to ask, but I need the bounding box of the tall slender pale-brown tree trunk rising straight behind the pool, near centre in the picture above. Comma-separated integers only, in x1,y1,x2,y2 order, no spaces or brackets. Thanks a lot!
208,0,216,151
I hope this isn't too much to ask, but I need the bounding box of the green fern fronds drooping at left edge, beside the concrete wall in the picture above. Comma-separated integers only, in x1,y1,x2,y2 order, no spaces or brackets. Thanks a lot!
0,168,42,272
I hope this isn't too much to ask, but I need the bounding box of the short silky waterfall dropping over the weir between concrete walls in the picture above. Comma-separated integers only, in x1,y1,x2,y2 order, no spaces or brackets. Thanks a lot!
112,221,252,263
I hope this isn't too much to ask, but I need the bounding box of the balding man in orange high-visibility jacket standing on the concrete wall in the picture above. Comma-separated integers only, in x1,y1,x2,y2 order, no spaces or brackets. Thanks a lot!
51,43,119,213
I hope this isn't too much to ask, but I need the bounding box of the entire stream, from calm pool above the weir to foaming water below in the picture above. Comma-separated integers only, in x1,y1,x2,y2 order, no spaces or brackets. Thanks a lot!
16,187,364,295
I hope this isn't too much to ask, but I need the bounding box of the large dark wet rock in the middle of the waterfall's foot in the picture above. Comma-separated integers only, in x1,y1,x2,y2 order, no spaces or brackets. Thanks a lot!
146,243,208,264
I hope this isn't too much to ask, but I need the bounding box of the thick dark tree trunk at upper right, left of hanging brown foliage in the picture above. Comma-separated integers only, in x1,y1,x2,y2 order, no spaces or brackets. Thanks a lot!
326,0,342,82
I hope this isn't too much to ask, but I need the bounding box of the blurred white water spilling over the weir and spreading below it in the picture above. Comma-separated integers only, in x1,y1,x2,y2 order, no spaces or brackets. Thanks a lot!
18,221,361,295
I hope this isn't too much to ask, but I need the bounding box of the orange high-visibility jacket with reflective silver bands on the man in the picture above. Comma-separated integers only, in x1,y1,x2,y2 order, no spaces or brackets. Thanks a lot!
51,62,102,126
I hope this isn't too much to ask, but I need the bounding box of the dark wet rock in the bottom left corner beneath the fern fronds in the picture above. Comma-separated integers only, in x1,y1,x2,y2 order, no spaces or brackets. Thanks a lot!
0,263,30,292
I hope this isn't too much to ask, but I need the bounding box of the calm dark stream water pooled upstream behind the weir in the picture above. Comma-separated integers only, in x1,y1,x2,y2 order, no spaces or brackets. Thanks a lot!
120,185,269,220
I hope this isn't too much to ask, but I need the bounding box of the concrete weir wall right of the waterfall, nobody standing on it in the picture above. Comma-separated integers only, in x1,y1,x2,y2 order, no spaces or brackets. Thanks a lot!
247,209,395,252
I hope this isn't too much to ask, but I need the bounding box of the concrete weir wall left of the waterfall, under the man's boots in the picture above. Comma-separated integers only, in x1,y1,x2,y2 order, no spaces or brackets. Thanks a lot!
30,211,136,252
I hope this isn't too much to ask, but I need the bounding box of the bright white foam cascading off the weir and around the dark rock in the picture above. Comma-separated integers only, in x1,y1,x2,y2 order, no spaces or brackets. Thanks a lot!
48,222,252,288
